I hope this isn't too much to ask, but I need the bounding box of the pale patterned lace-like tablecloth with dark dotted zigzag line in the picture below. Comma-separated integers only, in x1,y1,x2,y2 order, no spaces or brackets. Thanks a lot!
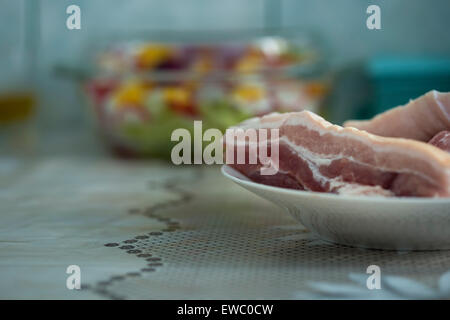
0,156,450,299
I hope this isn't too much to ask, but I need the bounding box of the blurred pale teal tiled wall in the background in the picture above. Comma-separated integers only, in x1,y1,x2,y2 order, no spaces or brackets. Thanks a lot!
0,0,450,126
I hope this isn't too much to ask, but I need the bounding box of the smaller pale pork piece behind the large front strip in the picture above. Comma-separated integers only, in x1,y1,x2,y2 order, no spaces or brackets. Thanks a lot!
344,91,450,142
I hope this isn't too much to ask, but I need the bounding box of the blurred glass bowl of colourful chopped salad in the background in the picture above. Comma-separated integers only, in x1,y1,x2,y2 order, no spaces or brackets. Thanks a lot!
83,32,327,157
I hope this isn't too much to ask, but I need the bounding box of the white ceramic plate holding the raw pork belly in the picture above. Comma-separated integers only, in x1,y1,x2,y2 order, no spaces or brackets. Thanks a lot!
222,165,450,250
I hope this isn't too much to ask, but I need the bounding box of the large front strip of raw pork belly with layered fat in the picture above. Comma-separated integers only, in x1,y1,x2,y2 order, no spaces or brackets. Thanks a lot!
224,111,450,197
